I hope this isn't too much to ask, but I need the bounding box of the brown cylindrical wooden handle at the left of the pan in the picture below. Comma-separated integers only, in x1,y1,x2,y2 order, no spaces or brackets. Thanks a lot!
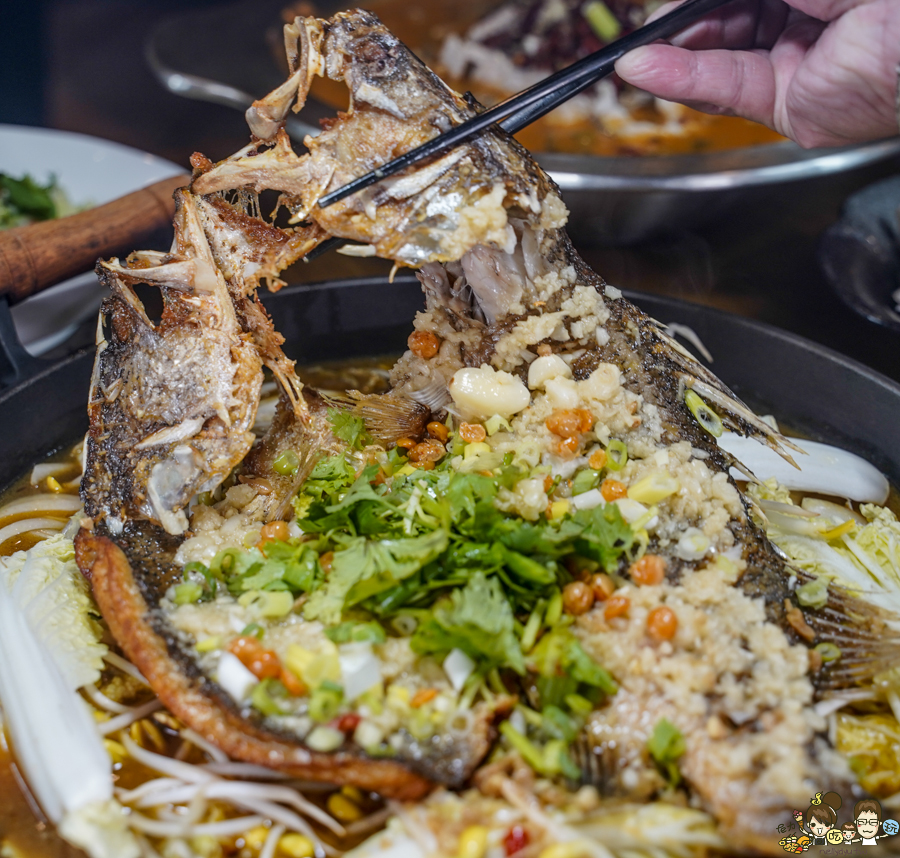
0,174,190,304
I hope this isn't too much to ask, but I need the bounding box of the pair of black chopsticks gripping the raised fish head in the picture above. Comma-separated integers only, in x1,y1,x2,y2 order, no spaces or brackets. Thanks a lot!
319,0,732,209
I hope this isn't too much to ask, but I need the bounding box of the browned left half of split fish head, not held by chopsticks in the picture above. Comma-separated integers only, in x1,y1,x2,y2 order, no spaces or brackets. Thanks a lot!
81,191,262,534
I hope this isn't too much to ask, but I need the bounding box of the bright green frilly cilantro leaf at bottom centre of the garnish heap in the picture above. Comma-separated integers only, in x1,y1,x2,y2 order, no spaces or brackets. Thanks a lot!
410,572,525,673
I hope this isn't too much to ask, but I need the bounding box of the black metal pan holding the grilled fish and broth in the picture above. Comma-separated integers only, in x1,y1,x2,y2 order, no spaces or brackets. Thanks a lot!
0,276,900,486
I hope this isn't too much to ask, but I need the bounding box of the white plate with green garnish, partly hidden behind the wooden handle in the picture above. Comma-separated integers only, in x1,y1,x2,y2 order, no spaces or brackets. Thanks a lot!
0,125,184,355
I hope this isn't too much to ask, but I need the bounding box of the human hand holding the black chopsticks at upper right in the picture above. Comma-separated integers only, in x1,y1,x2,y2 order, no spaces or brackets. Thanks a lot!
616,0,900,147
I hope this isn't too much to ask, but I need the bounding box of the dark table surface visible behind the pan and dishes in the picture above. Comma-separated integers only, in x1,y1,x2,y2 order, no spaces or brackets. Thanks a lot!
12,0,900,381
